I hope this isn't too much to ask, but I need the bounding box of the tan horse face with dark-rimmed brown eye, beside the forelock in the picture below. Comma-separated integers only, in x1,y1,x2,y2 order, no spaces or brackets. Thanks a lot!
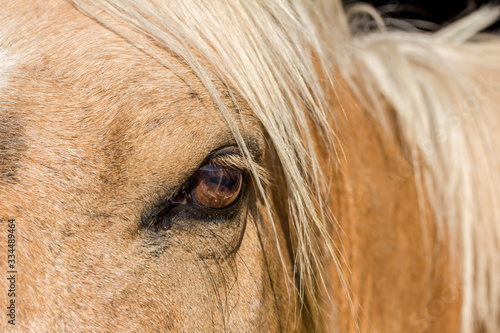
0,3,296,332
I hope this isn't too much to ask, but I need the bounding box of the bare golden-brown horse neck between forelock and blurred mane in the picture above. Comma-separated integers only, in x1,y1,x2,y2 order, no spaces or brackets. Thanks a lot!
318,76,461,332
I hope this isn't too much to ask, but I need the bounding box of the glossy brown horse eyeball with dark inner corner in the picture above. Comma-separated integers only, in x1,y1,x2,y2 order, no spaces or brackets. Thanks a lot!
172,164,244,209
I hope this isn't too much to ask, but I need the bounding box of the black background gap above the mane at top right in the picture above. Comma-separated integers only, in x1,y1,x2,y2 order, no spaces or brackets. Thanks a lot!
343,0,500,33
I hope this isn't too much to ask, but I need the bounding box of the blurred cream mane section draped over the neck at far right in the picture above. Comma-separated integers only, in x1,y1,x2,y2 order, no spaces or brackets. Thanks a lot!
323,5,500,332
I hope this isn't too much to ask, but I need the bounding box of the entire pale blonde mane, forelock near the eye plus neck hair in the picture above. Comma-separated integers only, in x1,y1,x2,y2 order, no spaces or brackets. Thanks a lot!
71,0,500,332
